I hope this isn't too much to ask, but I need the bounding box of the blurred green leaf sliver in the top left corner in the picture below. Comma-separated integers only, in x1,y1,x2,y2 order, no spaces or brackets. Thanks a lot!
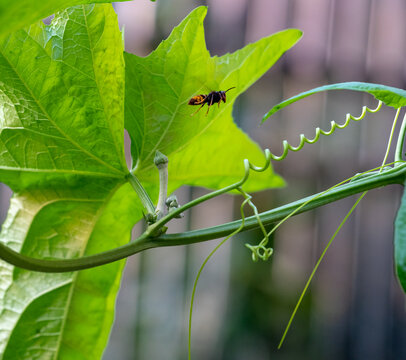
0,0,128,38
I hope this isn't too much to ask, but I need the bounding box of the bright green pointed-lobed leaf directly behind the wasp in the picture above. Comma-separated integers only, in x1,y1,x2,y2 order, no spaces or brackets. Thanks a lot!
125,7,301,191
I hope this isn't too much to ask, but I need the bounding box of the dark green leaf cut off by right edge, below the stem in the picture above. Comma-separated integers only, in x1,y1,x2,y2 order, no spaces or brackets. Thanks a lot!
394,180,406,294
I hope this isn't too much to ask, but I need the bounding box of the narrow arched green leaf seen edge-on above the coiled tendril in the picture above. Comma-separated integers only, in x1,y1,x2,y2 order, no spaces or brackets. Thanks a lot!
262,81,406,122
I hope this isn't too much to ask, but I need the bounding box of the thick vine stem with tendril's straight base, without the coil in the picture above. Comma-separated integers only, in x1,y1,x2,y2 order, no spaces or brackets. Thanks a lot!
0,164,406,272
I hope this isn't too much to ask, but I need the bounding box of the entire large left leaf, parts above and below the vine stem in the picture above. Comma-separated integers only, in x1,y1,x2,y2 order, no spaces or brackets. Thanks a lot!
0,5,141,360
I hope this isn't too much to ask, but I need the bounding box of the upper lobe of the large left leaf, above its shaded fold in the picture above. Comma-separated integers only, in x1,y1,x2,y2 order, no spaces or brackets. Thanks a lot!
0,5,127,190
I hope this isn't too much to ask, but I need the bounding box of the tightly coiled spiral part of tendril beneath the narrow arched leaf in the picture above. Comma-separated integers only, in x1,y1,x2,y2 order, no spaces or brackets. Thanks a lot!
270,101,382,161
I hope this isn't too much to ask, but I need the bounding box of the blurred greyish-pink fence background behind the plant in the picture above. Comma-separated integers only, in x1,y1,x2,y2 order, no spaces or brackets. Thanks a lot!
103,0,406,360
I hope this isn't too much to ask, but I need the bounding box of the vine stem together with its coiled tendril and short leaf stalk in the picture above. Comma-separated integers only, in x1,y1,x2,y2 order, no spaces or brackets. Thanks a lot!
0,102,406,272
